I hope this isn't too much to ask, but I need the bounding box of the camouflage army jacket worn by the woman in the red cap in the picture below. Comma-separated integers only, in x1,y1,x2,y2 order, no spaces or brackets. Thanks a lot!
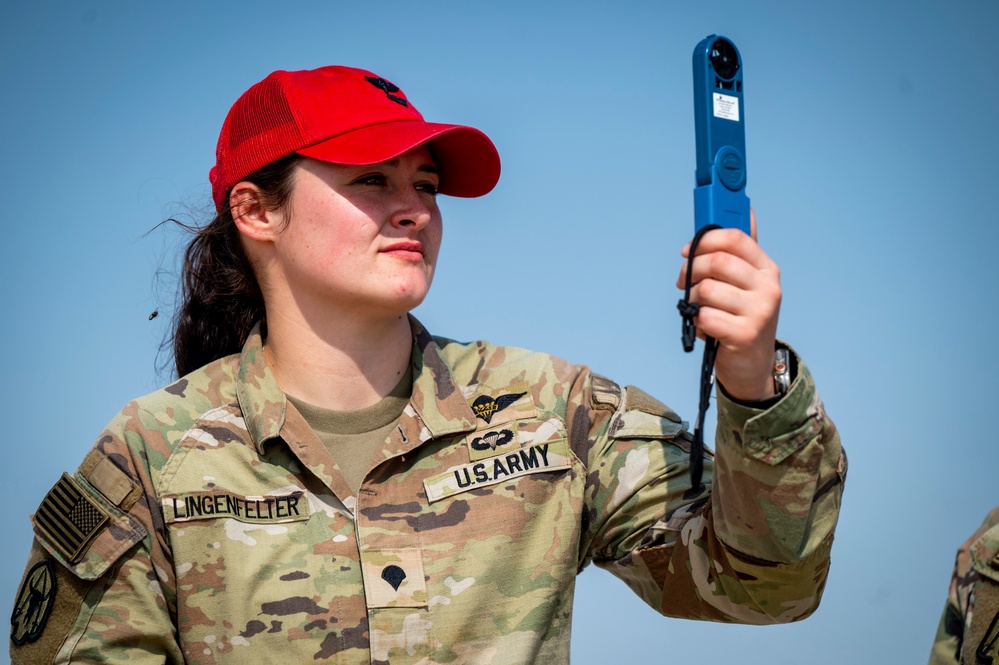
12,320,846,665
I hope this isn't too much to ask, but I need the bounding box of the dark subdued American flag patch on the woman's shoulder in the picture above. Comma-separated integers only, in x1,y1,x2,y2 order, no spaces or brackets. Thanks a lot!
35,473,110,563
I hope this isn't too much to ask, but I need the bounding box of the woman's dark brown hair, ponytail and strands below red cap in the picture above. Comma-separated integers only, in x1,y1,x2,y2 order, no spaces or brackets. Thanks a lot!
172,154,302,376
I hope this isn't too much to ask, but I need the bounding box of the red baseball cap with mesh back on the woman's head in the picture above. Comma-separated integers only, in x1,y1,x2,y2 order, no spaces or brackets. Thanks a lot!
214,66,500,210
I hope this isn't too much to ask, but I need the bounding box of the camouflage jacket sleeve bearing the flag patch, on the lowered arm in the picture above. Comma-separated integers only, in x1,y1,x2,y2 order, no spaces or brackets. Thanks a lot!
10,408,184,665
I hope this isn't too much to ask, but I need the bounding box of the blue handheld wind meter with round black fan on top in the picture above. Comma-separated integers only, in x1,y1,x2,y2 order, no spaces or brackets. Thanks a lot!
694,35,750,235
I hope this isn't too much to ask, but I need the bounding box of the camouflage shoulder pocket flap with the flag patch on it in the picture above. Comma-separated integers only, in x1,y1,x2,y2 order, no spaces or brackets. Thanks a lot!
31,473,147,580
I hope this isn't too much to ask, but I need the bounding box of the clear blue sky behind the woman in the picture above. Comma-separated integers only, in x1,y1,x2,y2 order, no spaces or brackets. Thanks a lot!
0,0,999,665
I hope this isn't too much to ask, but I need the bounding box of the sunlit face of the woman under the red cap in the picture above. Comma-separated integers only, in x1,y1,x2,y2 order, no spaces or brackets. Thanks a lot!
265,147,442,316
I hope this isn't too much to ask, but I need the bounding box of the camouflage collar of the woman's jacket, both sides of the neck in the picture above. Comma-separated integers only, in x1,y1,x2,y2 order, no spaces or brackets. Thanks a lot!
236,315,475,454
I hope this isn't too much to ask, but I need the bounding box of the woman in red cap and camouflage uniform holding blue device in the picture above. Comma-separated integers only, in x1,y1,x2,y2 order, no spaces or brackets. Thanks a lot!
11,67,845,664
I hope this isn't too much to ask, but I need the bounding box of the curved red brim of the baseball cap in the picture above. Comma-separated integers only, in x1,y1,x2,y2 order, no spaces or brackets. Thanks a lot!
296,121,500,197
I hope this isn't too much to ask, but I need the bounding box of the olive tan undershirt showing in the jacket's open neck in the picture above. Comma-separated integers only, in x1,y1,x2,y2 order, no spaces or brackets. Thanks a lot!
288,365,413,496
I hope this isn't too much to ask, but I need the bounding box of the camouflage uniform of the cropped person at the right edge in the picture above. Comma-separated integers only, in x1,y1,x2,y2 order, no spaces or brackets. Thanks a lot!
930,507,999,665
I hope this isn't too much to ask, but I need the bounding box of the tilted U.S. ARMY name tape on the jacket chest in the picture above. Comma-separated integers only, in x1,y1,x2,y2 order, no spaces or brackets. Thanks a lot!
423,439,572,502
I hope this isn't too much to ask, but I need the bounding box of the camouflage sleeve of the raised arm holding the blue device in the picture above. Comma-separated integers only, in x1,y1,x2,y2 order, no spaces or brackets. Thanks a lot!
568,342,847,624
